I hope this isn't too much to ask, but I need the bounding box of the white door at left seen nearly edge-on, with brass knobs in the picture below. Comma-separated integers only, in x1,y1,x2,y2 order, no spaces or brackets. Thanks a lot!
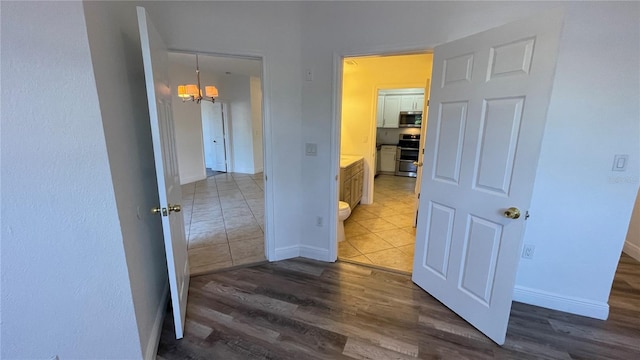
137,7,189,339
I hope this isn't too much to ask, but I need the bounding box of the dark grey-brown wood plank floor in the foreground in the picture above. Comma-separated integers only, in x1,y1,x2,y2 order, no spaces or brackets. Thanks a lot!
158,255,640,360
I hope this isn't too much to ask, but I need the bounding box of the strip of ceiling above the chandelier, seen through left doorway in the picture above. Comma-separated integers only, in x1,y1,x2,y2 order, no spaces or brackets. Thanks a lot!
169,52,262,77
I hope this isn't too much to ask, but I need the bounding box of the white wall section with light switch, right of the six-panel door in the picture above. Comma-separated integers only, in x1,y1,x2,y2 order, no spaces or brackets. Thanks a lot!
516,3,640,316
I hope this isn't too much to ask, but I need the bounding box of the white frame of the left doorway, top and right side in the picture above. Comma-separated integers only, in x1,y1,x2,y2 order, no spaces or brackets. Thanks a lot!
169,48,274,261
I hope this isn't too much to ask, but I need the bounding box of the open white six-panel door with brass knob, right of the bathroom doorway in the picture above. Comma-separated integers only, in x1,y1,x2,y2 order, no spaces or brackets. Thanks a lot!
413,12,562,345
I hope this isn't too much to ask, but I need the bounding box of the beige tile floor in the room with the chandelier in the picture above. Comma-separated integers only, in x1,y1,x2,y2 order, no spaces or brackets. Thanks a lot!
182,173,266,275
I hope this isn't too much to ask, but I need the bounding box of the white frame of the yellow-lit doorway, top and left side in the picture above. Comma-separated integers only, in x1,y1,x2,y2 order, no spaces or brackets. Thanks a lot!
328,45,435,261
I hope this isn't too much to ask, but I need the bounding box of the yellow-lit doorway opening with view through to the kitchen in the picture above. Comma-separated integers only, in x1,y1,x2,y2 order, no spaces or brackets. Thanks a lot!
338,53,433,272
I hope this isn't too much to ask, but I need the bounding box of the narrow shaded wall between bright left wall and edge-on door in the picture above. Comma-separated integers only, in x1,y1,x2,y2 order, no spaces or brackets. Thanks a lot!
84,1,169,358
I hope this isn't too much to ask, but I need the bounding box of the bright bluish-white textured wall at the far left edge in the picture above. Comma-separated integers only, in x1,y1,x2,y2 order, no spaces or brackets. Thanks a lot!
0,2,142,359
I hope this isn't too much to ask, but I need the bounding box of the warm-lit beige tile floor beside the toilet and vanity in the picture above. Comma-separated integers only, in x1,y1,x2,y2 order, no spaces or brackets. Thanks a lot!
338,175,416,272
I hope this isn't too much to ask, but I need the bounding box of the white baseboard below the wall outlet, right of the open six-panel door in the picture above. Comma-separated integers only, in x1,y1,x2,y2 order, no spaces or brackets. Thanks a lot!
513,286,609,320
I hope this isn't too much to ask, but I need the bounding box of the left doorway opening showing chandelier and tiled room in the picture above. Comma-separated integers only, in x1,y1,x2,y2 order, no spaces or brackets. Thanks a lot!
169,52,266,275
